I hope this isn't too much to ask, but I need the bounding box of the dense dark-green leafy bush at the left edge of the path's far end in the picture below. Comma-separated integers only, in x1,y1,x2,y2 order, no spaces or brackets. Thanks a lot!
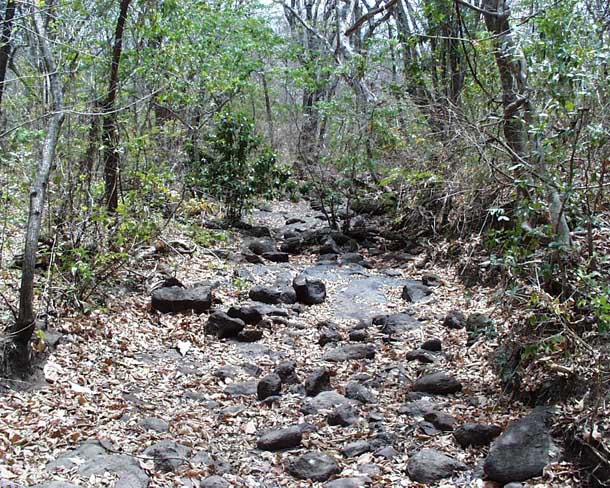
192,112,289,220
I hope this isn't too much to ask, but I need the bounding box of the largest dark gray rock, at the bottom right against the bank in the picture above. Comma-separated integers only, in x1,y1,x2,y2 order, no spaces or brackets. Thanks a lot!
483,408,556,484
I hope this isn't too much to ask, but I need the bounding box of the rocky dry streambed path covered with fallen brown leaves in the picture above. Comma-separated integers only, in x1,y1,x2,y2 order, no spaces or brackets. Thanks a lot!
0,203,579,488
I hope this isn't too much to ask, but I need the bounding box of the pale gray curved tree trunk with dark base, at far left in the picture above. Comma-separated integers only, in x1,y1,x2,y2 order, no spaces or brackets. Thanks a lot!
9,8,64,374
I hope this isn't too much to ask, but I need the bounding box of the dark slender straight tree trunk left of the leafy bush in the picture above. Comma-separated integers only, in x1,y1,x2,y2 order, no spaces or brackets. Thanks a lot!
102,0,131,213
